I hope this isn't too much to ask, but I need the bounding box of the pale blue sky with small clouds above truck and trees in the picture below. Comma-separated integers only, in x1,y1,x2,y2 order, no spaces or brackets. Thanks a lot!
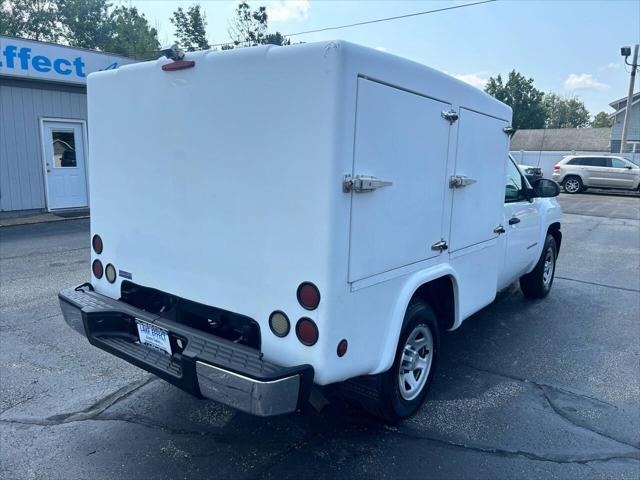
132,0,640,114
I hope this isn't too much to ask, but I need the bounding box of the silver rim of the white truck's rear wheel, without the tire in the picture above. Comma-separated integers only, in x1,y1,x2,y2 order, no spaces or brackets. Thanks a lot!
398,325,433,400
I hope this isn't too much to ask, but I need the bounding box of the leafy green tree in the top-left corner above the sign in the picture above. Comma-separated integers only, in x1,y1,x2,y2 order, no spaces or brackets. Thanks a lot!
0,0,60,42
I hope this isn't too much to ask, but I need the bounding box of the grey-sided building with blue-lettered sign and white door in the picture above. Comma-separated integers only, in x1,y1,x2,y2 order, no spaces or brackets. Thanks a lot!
0,36,136,216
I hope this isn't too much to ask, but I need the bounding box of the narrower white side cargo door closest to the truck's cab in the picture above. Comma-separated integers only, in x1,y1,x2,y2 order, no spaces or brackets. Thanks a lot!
449,108,509,253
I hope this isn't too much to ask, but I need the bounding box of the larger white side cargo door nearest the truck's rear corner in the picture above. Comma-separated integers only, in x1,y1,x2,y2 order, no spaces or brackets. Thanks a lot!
349,78,450,282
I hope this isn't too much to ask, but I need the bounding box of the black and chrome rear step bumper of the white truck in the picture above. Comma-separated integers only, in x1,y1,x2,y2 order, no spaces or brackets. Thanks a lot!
58,284,314,417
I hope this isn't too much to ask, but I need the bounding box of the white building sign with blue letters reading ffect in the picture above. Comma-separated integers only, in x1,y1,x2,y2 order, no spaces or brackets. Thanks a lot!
0,36,137,84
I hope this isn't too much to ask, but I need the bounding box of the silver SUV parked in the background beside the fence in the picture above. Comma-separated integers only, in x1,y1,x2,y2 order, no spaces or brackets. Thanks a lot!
552,155,640,193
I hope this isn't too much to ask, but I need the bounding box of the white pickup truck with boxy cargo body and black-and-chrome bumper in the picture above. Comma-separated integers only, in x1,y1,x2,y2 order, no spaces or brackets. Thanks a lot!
59,41,561,420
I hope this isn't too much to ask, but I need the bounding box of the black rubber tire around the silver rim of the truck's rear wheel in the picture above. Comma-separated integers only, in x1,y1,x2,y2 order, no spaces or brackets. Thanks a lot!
361,300,440,423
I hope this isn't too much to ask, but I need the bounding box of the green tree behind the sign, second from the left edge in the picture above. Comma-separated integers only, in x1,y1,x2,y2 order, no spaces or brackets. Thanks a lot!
57,0,112,49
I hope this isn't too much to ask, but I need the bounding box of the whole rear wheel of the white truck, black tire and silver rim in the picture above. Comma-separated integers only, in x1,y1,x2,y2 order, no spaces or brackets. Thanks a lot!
363,300,440,422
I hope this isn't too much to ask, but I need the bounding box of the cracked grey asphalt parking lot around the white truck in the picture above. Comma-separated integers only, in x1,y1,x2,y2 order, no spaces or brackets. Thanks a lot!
0,193,640,480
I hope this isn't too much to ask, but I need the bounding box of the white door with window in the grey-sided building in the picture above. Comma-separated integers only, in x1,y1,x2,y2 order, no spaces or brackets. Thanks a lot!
42,120,88,210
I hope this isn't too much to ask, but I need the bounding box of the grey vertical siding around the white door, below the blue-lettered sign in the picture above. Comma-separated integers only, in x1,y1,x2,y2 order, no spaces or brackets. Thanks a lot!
0,78,87,211
